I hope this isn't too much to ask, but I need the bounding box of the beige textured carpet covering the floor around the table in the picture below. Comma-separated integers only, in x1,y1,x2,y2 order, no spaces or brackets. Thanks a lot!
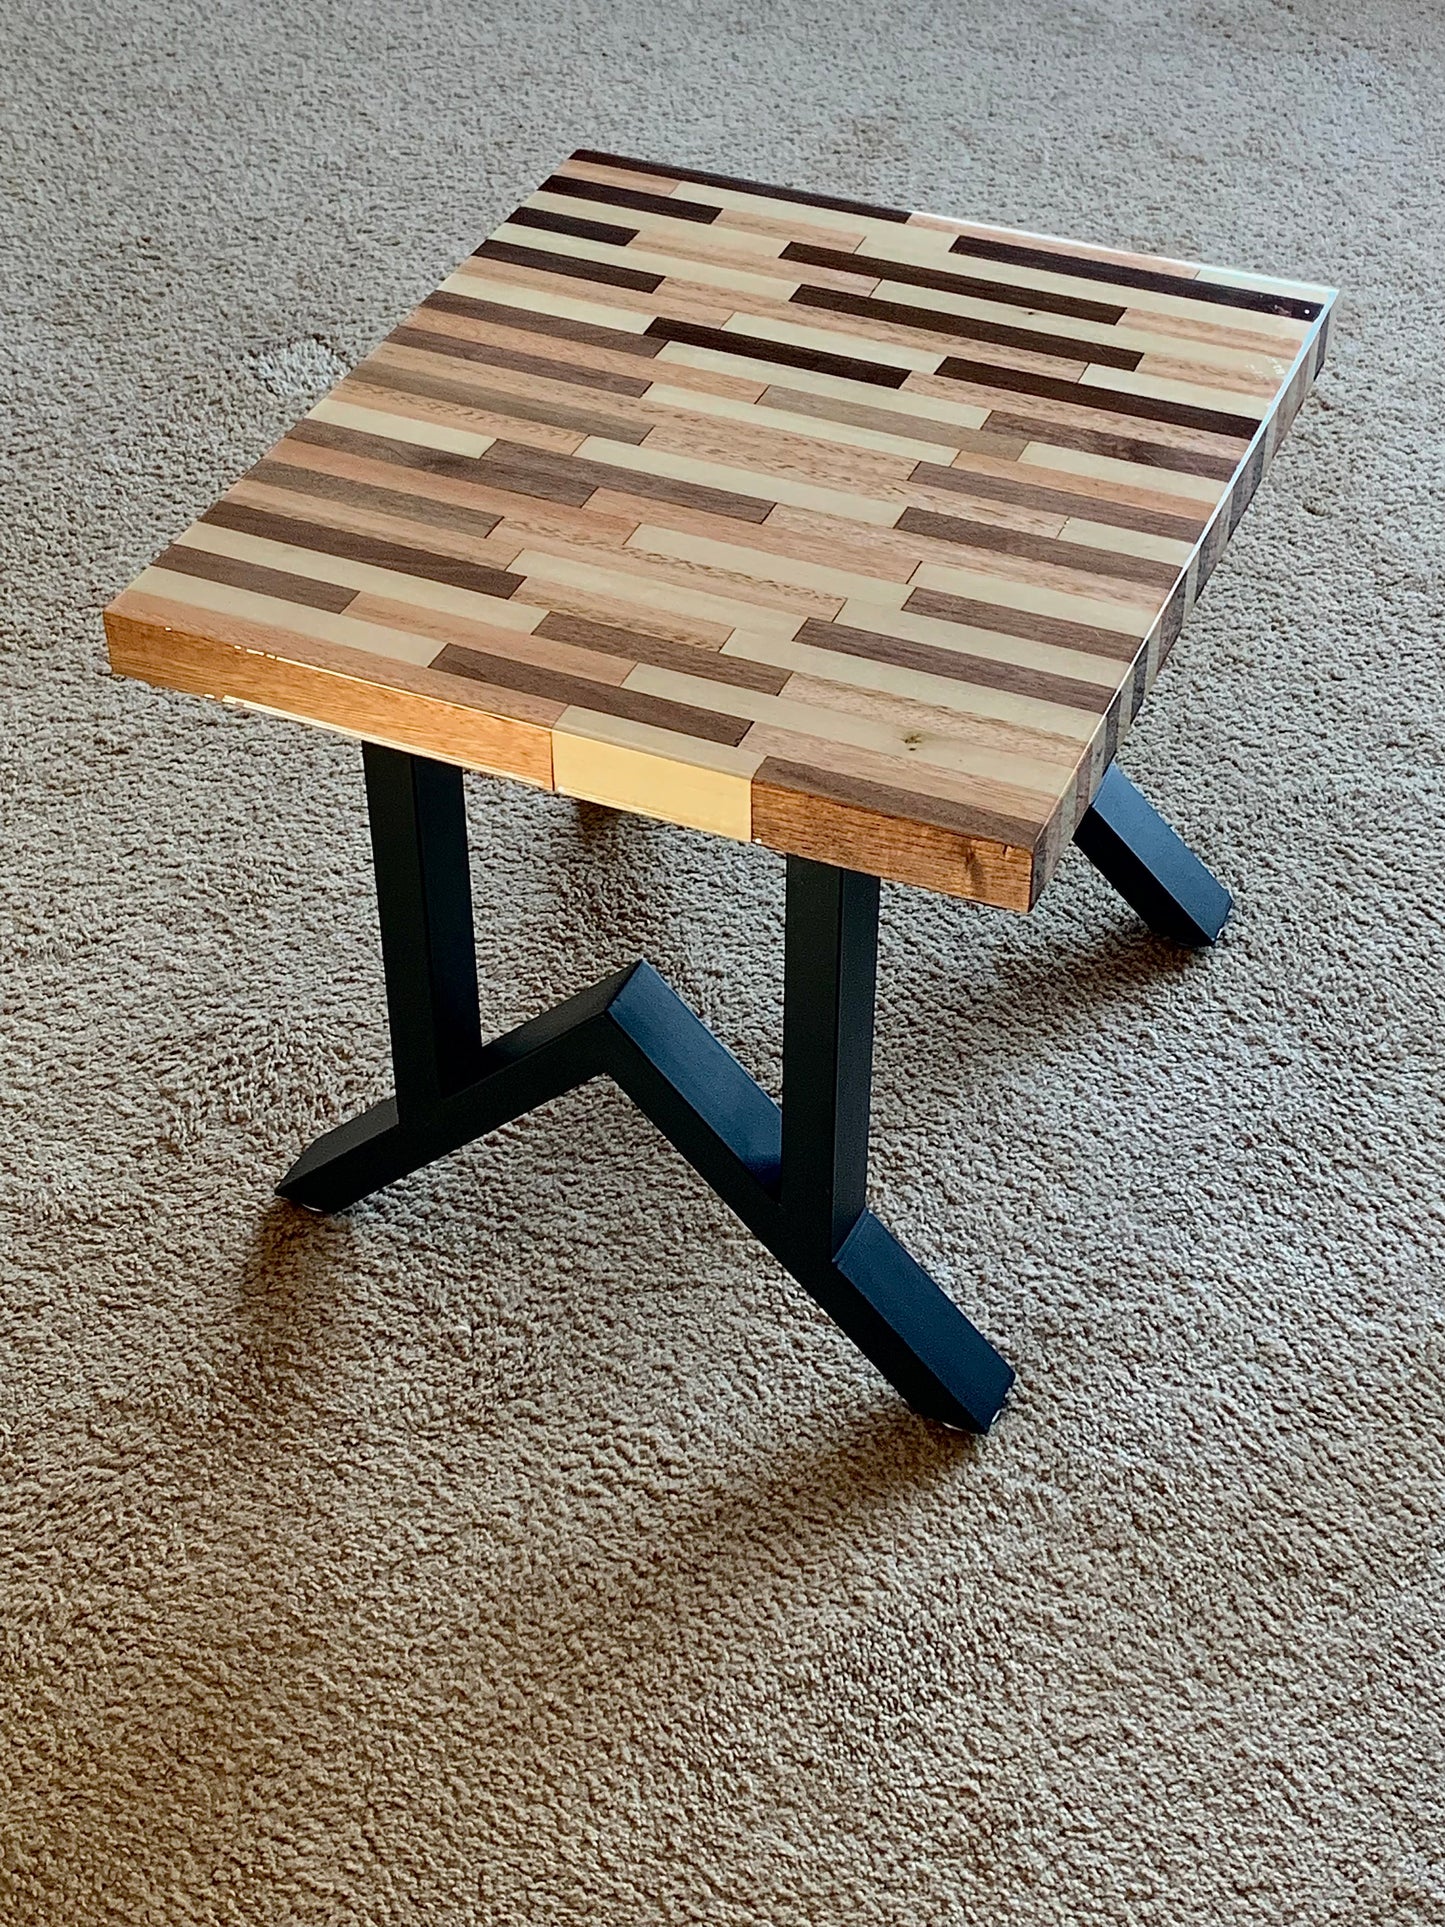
0,0,1445,1927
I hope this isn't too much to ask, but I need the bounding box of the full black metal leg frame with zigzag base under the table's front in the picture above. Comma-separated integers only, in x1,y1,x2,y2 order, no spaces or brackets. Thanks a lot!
279,746,1013,1432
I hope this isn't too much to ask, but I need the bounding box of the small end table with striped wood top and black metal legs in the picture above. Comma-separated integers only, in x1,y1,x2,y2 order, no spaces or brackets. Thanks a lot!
106,150,1333,1430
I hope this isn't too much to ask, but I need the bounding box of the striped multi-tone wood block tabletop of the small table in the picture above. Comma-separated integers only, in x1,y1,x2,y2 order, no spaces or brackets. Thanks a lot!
106,150,1333,910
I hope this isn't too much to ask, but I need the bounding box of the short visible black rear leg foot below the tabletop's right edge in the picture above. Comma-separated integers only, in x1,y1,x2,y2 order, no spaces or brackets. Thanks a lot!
1073,763,1233,950
